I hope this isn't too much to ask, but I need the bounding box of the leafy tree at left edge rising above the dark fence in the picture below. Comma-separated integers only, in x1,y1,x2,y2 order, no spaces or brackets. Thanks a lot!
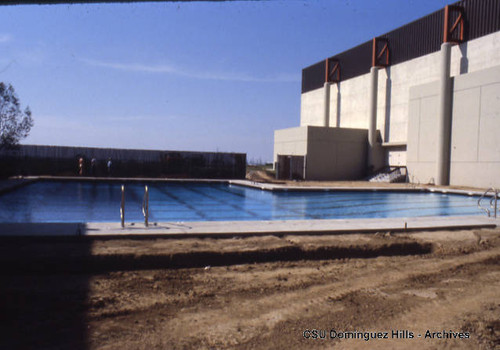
0,82,33,149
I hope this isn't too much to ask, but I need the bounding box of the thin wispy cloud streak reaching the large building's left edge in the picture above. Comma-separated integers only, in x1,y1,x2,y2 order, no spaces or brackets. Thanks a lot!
80,58,300,83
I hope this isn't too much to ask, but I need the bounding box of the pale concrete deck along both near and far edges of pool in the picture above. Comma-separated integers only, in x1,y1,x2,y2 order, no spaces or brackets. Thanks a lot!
0,176,500,238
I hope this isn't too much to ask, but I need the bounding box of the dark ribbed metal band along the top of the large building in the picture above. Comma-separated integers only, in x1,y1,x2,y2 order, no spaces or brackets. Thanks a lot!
302,0,500,93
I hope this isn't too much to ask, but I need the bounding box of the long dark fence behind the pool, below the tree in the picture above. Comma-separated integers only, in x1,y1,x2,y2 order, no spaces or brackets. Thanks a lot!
0,145,246,179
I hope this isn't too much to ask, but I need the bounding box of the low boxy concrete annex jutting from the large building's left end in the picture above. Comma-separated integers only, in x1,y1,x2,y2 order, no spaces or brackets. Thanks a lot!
274,126,368,180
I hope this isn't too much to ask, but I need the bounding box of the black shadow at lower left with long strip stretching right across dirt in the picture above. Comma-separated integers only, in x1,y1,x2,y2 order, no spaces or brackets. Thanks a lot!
0,236,432,350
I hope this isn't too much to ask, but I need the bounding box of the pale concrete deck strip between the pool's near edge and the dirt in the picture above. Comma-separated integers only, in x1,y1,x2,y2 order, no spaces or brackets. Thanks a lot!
0,216,500,238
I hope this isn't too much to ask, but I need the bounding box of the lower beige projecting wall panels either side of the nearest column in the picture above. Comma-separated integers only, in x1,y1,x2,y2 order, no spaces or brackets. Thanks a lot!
407,65,500,187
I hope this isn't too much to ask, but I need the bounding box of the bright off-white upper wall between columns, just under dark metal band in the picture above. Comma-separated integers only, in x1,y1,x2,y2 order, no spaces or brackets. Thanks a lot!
300,32,500,165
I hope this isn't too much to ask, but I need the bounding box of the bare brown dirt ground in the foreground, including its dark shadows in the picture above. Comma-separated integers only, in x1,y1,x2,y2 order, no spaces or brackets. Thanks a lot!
0,228,500,350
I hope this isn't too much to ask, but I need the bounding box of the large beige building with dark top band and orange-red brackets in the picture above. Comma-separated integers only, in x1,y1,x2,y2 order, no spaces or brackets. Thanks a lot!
274,0,500,187
